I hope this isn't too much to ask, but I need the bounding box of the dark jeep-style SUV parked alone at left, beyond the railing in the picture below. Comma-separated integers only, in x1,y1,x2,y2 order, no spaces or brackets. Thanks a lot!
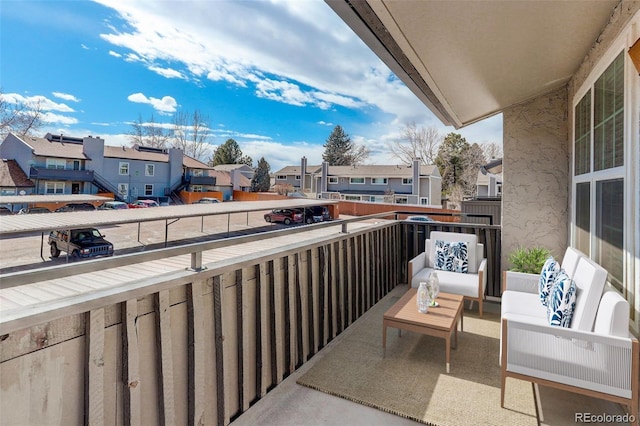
49,228,113,258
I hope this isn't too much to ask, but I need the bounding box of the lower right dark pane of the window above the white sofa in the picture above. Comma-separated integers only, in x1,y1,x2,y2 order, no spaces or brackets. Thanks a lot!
595,179,624,291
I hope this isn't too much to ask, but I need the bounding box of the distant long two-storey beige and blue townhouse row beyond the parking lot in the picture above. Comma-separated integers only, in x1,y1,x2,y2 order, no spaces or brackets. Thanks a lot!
314,159,442,206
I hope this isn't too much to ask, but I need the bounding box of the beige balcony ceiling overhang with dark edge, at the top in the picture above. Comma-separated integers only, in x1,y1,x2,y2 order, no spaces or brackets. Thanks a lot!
325,0,619,128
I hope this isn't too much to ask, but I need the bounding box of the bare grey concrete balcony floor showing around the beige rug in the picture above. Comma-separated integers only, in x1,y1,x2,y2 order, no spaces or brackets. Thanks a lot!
232,285,626,426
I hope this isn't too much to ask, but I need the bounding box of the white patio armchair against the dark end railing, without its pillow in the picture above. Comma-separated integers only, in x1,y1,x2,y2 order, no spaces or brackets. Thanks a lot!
408,231,487,318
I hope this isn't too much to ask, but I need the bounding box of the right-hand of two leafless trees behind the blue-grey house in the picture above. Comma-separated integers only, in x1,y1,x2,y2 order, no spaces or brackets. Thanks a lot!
173,110,212,161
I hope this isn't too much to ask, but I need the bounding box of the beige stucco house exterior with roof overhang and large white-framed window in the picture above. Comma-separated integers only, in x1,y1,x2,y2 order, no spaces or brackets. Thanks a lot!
326,0,640,330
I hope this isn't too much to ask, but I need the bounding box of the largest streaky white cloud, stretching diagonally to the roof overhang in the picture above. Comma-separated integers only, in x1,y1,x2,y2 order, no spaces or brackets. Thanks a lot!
91,0,430,123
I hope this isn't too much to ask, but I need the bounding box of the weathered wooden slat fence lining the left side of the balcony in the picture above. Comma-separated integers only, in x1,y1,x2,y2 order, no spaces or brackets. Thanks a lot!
0,222,400,425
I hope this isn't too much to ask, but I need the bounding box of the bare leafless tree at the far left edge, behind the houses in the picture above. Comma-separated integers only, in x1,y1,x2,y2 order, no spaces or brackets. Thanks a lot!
0,90,44,140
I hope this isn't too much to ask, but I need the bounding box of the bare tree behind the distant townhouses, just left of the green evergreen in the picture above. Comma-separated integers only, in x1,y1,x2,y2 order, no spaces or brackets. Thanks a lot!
389,123,443,165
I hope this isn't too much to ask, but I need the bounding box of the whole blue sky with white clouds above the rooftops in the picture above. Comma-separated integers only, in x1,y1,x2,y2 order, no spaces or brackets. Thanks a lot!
0,0,502,171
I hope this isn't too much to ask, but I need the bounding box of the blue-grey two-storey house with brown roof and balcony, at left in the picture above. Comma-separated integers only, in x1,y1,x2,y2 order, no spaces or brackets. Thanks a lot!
0,134,208,202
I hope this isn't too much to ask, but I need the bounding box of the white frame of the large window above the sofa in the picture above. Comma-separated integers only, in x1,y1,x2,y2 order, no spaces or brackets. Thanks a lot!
570,23,640,316
